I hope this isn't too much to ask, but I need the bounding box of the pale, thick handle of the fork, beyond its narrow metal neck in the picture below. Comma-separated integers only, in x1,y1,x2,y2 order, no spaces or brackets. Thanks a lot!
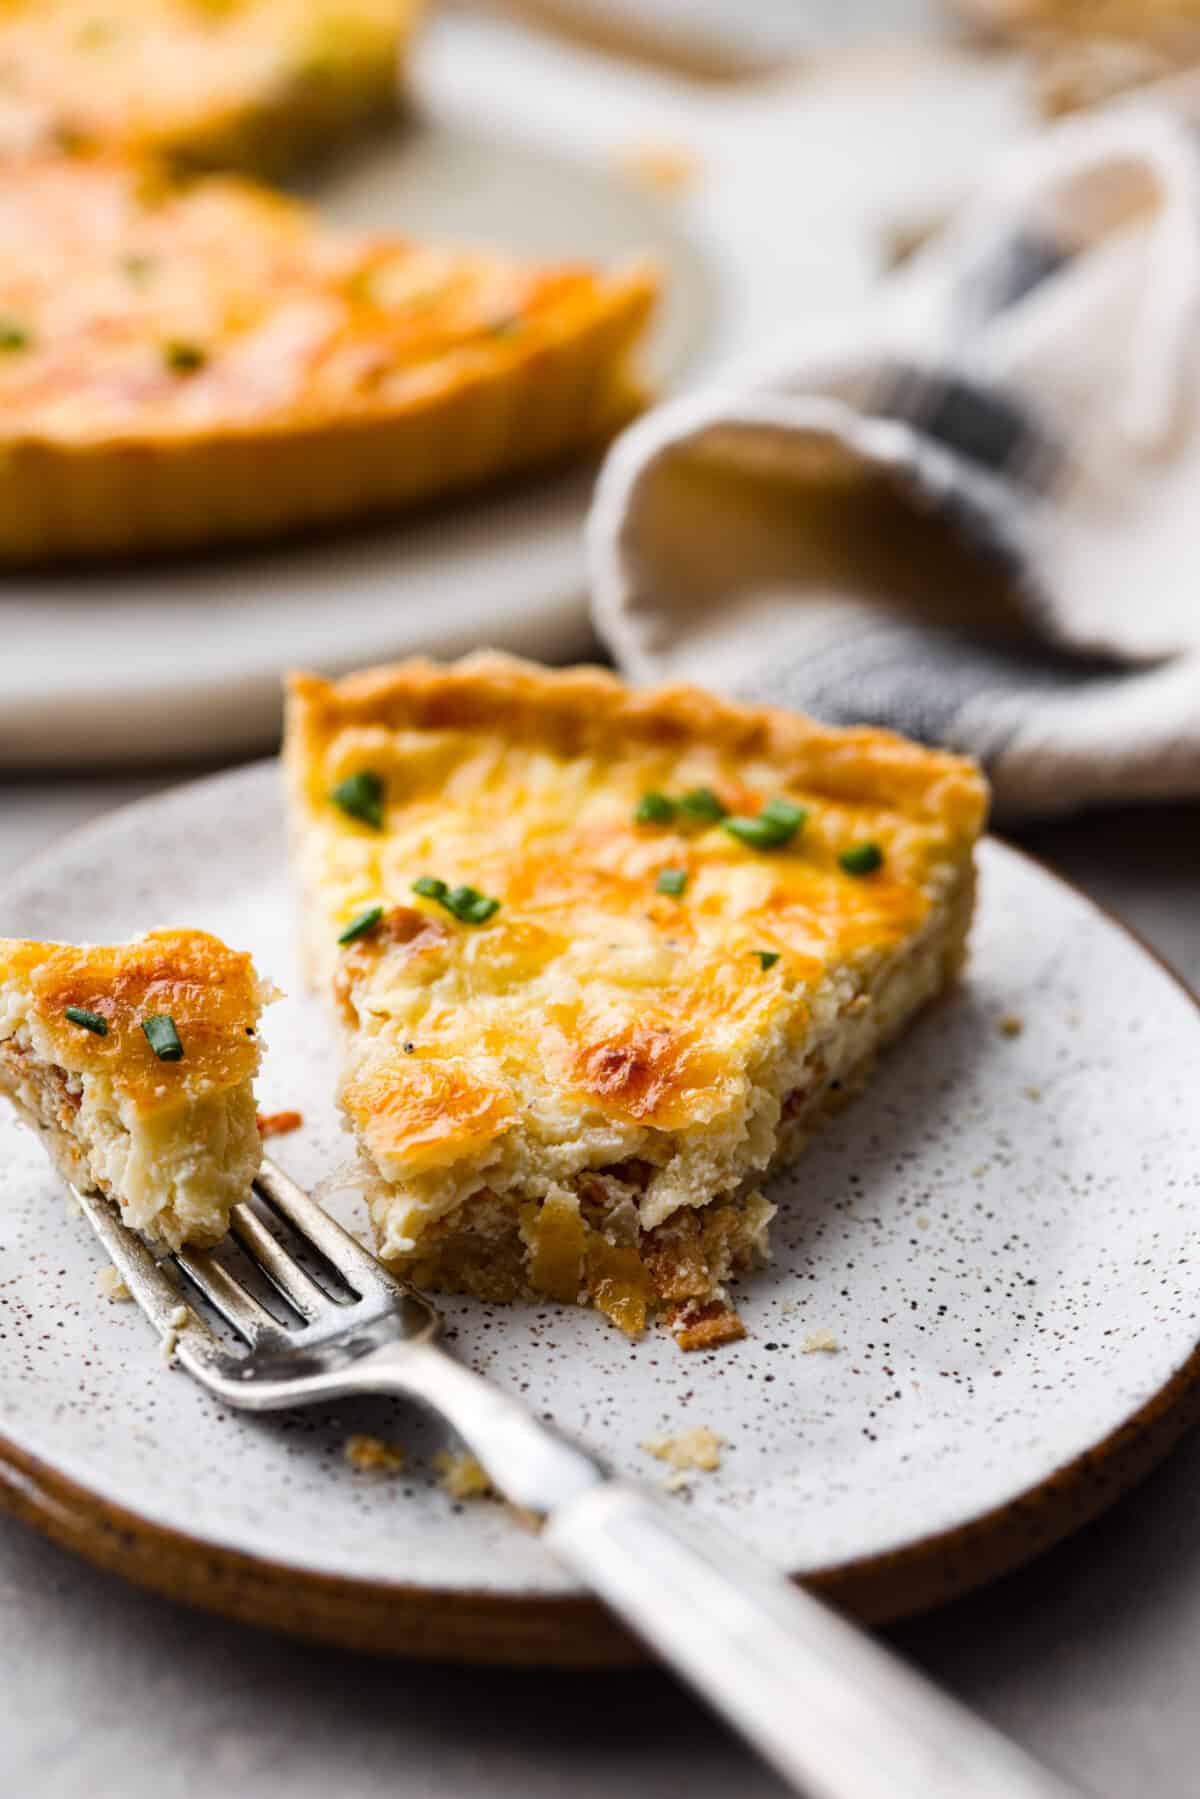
545,1482,1078,1799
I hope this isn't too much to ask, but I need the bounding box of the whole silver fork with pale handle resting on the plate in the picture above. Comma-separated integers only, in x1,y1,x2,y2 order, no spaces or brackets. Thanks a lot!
76,1162,1070,1799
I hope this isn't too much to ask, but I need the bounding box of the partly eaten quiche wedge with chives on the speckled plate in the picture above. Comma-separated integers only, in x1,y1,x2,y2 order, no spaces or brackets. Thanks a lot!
286,655,986,1347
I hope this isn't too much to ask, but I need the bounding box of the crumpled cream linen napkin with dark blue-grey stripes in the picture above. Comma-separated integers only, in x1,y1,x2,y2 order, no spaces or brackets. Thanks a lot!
588,92,1200,819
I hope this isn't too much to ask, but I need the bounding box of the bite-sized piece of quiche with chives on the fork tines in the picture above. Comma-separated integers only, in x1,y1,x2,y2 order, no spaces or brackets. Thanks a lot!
0,930,272,1249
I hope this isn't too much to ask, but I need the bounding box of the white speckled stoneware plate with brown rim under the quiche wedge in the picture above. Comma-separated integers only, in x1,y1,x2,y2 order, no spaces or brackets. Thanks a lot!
0,765,1200,1662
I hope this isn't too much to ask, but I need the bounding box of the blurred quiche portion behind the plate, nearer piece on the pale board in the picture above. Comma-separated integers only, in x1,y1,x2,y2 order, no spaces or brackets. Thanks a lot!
0,157,655,561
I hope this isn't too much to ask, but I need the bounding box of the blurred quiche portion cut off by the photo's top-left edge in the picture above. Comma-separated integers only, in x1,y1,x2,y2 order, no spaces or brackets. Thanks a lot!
0,0,417,173
